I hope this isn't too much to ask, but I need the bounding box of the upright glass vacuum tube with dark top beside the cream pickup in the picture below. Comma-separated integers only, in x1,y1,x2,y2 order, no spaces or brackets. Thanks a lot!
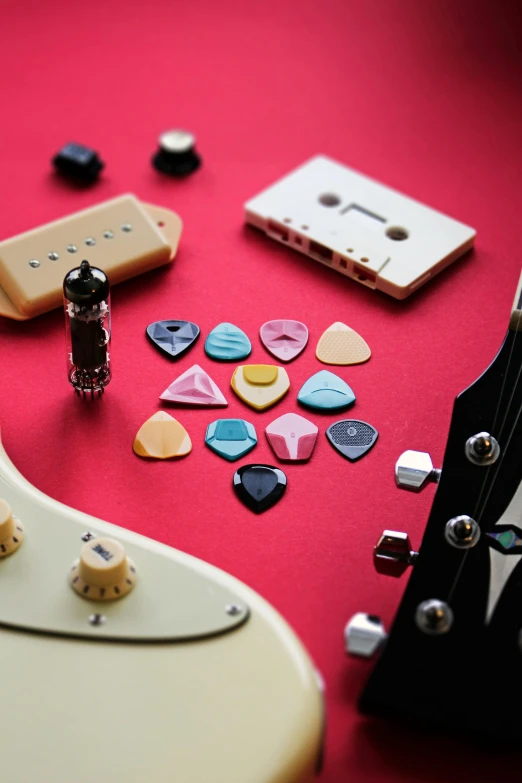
63,261,111,397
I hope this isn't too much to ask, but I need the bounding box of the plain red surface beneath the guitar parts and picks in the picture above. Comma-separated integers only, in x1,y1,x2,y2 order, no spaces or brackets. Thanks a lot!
0,0,522,783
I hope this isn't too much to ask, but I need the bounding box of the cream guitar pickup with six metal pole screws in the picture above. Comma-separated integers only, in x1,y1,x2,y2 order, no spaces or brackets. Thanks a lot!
0,194,182,321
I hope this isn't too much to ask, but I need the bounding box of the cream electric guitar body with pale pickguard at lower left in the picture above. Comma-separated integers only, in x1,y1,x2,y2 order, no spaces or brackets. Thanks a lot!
0,434,323,783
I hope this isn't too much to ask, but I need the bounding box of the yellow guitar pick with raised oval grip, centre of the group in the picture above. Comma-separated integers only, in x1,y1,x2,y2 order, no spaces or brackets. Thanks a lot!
230,364,290,411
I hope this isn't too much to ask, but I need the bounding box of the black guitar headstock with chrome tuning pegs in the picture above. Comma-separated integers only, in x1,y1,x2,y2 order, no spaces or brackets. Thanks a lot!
346,276,522,740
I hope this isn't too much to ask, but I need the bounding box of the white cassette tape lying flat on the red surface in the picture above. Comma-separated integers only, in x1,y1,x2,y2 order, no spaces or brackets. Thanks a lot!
245,155,476,299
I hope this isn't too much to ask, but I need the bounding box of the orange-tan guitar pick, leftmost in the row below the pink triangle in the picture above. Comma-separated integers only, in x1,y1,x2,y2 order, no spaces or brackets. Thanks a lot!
132,411,192,459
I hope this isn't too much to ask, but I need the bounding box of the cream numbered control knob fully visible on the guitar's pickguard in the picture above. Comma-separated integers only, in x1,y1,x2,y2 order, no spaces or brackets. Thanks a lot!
69,537,136,601
